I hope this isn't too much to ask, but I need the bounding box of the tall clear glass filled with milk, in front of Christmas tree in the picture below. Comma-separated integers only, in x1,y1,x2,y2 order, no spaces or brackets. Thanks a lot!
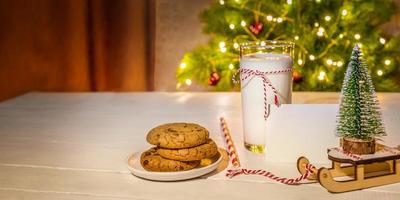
240,41,294,153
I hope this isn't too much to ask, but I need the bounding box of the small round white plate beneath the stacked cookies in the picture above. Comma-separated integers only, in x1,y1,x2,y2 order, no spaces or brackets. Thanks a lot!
128,150,222,181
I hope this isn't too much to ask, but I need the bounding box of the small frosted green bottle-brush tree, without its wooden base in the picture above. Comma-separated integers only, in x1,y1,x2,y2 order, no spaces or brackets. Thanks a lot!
336,45,385,140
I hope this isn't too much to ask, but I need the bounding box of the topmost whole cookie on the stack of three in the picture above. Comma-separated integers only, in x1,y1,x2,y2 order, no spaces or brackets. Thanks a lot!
147,123,209,149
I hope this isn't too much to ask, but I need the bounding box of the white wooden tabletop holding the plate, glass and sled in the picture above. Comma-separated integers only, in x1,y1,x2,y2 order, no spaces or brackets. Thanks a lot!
0,93,400,200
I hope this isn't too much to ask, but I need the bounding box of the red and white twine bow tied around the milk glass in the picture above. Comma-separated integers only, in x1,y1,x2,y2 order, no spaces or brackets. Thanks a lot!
232,67,292,120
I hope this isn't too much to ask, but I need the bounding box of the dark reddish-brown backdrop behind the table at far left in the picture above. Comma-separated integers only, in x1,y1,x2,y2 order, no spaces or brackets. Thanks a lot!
0,0,152,100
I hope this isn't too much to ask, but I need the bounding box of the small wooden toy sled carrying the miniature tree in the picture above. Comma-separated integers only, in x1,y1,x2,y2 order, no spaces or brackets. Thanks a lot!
297,148,400,193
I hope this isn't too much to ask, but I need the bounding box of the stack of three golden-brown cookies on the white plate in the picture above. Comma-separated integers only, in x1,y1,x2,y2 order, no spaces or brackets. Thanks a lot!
140,123,218,172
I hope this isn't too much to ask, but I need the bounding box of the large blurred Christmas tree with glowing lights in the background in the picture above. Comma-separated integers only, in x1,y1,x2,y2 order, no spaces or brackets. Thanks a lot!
177,0,400,91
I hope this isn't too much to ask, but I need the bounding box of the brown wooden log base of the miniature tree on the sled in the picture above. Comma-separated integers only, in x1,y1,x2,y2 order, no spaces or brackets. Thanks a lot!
342,138,375,155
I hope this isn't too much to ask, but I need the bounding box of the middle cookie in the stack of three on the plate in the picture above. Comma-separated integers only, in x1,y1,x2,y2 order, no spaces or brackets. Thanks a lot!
158,139,218,161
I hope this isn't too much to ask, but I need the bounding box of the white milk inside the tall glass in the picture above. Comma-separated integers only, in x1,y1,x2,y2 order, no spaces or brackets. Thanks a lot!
240,53,293,150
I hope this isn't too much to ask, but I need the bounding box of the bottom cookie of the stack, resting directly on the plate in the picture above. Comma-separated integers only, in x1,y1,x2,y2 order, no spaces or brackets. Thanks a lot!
140,148,200,172
